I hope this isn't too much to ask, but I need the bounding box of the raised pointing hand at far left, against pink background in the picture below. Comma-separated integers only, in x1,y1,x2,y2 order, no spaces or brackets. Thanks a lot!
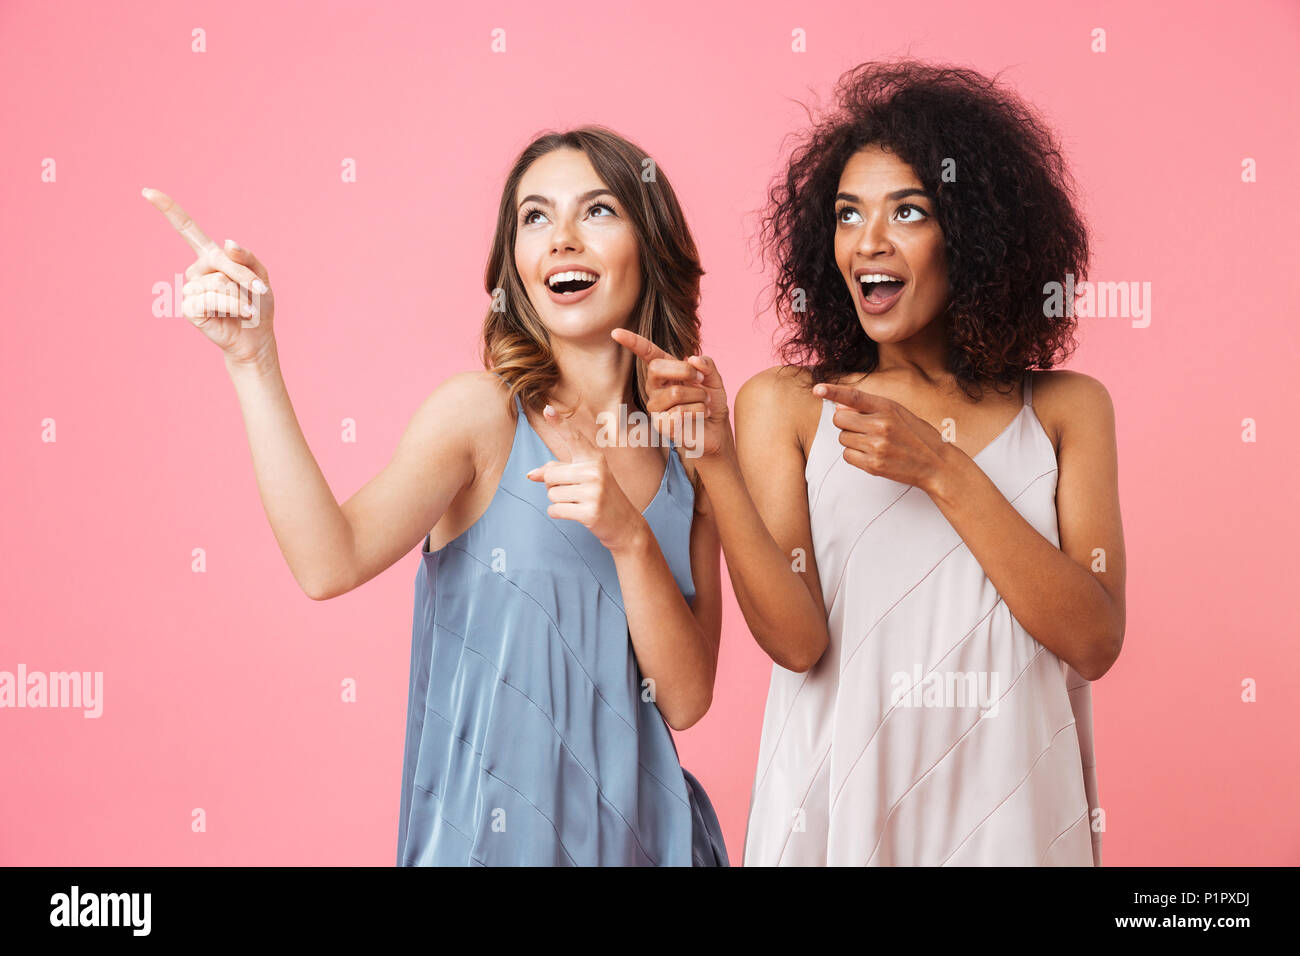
142,187,276,365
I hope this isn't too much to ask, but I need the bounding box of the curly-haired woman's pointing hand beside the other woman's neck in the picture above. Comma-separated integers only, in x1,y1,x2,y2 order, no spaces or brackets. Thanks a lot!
610,329,732,458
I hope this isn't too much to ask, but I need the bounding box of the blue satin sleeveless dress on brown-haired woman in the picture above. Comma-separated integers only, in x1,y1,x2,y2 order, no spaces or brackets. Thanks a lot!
397,387,728,866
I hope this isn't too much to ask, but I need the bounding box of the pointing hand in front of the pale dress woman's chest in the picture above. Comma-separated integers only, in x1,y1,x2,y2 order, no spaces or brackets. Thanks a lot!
813,384,954,494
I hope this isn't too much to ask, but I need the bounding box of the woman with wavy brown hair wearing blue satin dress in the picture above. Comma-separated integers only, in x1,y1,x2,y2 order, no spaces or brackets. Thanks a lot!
146,126,727,866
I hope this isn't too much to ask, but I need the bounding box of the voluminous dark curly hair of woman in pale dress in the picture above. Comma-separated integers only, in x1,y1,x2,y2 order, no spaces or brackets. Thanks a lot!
762,59,1088,399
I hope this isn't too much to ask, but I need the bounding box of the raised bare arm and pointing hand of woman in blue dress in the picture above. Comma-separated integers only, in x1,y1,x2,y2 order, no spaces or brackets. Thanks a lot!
142,187,488,600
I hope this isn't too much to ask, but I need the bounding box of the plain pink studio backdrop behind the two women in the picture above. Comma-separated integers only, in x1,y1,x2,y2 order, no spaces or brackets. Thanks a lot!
0,0,1300,866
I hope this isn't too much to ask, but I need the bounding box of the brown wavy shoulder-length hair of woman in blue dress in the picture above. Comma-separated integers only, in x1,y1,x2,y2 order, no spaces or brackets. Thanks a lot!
482,126,705,418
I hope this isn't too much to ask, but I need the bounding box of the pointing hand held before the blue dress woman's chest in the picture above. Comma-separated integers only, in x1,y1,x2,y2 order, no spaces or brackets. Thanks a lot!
528,406,649,553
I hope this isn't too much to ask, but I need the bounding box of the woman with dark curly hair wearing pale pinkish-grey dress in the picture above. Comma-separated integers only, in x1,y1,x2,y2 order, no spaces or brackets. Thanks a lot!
615,60,1125,865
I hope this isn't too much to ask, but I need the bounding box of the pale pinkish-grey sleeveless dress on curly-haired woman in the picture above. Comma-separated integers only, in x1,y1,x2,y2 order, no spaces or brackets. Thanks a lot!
744,373,1101,866
